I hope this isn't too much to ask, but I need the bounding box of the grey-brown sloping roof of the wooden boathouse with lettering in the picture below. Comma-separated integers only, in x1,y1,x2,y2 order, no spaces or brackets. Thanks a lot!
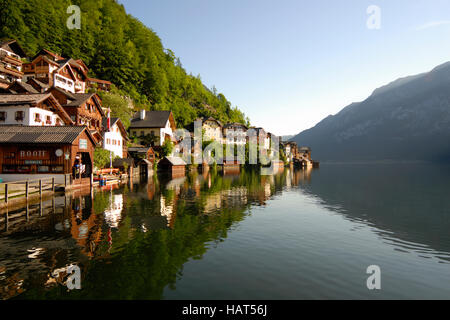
0,125,92,144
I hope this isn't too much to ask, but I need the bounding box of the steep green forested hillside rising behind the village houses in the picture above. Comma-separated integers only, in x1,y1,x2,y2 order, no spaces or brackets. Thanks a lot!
0,0,248,126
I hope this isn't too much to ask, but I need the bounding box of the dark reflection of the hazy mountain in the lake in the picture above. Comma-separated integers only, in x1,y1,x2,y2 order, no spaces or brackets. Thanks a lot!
303,165,450,257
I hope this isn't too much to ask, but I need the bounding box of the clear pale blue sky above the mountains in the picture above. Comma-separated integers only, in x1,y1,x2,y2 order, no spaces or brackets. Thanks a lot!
119,0,450,135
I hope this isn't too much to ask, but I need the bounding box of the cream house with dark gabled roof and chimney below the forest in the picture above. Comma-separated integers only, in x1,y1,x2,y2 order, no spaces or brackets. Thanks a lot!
128,110,176,146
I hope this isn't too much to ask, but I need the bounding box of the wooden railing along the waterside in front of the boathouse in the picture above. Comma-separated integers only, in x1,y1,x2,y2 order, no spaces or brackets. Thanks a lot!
0,177,55,204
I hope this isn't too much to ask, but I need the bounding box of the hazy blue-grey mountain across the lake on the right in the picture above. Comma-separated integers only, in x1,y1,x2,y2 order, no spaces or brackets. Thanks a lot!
292,62,450,161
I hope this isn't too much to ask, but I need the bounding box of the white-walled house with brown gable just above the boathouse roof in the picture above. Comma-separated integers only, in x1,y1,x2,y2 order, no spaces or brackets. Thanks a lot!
0,93,74,126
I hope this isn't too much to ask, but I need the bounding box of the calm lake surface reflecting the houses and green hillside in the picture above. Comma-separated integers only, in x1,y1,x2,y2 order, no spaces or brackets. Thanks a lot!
0,164,450,299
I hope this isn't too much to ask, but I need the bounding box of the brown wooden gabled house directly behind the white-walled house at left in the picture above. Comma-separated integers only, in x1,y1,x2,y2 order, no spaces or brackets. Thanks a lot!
48,87,105,143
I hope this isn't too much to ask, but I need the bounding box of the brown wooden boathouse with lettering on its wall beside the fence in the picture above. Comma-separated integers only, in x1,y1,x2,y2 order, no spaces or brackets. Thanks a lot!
0,125,95,184
